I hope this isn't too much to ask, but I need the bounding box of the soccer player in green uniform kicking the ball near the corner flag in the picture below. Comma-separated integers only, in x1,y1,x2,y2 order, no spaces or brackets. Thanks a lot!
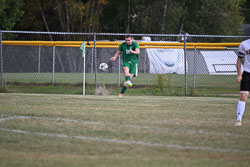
110,36,140,97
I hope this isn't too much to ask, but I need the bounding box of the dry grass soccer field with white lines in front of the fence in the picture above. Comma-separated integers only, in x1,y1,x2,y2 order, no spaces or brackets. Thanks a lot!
0,94,250,167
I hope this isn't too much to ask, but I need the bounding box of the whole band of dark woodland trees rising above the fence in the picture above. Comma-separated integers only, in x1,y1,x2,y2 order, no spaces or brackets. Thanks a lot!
0,0,250,35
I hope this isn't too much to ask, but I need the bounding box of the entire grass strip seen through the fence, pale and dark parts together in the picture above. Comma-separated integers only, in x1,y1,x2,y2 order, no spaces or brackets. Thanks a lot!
0,73,239,96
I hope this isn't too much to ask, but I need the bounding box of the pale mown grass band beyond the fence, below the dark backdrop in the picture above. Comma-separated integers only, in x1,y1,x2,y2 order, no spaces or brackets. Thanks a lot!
3,73,237,87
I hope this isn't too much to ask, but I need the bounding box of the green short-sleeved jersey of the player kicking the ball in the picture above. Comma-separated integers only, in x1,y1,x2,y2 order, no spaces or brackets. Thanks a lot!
119,41,139,63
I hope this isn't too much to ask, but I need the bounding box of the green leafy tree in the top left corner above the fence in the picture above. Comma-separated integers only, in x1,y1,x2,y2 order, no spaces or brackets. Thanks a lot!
0,0,23,30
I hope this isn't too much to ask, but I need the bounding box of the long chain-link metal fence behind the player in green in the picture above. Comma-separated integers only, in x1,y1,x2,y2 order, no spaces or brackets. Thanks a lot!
0,31,249,96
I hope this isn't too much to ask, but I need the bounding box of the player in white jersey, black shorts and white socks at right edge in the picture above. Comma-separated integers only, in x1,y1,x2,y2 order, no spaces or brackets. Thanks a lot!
235,39,250,126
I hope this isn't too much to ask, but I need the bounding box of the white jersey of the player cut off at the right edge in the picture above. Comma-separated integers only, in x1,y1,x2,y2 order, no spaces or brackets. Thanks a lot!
238,39,250,73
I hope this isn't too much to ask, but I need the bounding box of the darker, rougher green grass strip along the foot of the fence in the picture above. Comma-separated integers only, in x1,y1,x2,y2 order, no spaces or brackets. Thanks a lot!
0,83,238,97
